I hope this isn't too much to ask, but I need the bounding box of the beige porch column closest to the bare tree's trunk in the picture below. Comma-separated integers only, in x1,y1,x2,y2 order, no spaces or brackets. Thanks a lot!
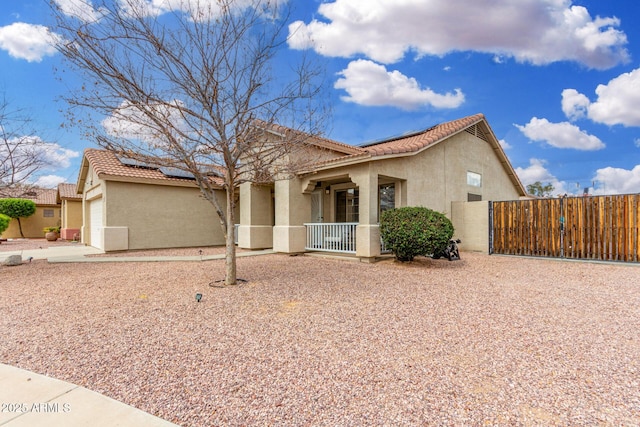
238,182,273,249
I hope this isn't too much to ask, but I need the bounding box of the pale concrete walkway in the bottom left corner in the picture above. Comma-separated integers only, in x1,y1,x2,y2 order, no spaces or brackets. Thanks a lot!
0,364,177,427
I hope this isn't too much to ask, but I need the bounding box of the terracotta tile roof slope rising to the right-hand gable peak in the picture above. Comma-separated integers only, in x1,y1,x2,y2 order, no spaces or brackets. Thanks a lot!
362,114,484,156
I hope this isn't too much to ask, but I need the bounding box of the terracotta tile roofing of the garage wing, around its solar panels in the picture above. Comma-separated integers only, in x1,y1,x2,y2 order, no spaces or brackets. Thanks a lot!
84,148,223,186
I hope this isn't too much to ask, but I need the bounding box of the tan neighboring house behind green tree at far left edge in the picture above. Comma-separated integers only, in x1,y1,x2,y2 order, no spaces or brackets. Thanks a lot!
2,188,60,239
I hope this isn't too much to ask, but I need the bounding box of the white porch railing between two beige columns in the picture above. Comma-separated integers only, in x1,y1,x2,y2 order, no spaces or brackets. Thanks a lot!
304,222,358,254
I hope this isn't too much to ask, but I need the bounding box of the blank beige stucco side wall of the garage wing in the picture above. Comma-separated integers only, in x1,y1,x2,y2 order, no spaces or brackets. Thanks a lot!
103,181,231,249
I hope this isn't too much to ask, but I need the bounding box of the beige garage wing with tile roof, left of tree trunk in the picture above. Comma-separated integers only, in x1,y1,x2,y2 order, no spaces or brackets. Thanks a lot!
77,149,235,251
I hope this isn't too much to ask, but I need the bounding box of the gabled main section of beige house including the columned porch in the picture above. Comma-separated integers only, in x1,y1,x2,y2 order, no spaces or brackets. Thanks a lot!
238,114,526,259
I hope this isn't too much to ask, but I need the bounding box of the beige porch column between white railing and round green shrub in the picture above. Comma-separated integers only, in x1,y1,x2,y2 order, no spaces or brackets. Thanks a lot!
351,168,380,259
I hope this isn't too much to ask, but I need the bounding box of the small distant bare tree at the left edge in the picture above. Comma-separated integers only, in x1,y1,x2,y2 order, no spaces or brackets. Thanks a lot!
0,99,57,197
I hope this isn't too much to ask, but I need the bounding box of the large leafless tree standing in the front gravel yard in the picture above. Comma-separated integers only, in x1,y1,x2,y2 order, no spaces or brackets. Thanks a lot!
51,0,324,285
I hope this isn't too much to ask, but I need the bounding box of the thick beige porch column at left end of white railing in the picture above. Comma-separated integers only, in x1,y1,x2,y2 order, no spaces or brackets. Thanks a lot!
273,178,311,253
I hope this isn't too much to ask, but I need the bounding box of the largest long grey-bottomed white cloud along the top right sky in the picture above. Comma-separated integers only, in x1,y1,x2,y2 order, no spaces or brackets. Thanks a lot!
289,0,629,69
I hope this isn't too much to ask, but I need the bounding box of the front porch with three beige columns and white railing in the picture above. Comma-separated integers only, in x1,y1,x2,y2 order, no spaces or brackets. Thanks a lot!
238,169,406,259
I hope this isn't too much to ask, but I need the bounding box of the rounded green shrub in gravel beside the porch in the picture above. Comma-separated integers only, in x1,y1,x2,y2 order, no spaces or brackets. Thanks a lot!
380,207,453,261
